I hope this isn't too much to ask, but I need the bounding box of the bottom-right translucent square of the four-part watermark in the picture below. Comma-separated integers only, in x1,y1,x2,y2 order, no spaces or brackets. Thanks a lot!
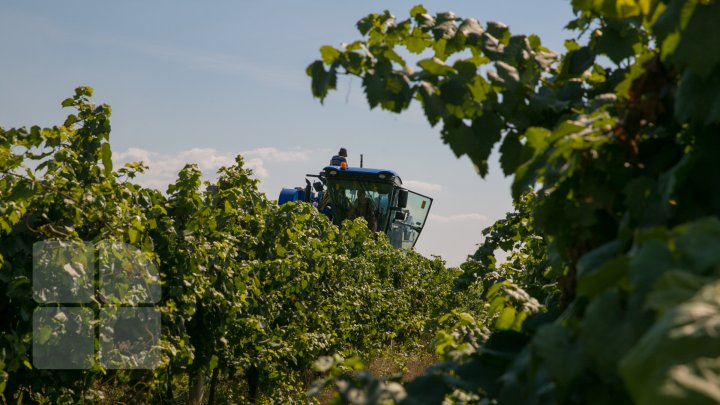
99,307,160,369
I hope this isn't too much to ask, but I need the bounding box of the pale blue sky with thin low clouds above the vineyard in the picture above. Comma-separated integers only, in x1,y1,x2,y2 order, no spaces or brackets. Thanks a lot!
0,0,572,265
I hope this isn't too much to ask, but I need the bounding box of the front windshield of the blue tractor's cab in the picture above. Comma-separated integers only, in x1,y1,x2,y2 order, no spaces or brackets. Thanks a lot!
328,180,393,232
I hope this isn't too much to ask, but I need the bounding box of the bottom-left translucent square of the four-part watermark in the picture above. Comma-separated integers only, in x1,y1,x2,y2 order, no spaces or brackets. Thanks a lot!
33,307,95,369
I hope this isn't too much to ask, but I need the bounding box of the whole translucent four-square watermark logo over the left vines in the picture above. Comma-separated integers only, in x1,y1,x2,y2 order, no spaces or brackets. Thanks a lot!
33,241,161,369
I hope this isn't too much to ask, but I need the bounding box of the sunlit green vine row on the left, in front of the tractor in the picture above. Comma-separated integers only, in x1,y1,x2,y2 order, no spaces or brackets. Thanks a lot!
0,87,458,403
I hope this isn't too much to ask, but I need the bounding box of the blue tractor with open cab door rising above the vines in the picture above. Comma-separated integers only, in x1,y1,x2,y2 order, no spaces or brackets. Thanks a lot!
278,164,433,250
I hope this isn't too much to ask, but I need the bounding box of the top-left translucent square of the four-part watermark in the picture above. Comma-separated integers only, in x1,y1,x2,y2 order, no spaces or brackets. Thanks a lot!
33,240,95,304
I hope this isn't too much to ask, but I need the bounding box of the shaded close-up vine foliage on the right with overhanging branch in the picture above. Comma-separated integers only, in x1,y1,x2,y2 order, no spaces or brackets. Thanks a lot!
307,0,720,403
